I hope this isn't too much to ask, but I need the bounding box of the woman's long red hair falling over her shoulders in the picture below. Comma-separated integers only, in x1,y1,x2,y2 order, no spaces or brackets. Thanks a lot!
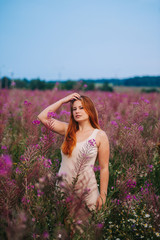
61,96,100,156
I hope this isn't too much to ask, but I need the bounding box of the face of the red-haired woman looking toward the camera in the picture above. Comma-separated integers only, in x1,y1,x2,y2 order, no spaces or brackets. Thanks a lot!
73,100,89,122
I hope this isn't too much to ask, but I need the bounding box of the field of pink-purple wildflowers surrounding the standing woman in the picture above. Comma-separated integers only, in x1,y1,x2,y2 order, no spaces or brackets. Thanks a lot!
0,88,160,240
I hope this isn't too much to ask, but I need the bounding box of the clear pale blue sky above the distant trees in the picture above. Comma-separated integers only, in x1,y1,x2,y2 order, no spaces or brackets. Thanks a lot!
0,0,160,81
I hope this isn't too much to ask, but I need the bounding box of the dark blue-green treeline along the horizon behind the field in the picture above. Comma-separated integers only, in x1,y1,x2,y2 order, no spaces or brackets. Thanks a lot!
0,76,160,91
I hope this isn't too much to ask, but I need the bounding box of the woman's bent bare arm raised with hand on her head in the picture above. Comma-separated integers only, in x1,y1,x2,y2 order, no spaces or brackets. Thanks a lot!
37,93,80,135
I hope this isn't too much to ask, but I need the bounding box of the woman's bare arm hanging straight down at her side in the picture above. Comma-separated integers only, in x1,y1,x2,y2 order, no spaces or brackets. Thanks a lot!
96,131,109,209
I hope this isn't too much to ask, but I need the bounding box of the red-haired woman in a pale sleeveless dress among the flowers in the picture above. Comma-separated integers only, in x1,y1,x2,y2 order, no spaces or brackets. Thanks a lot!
38,93,109,209
